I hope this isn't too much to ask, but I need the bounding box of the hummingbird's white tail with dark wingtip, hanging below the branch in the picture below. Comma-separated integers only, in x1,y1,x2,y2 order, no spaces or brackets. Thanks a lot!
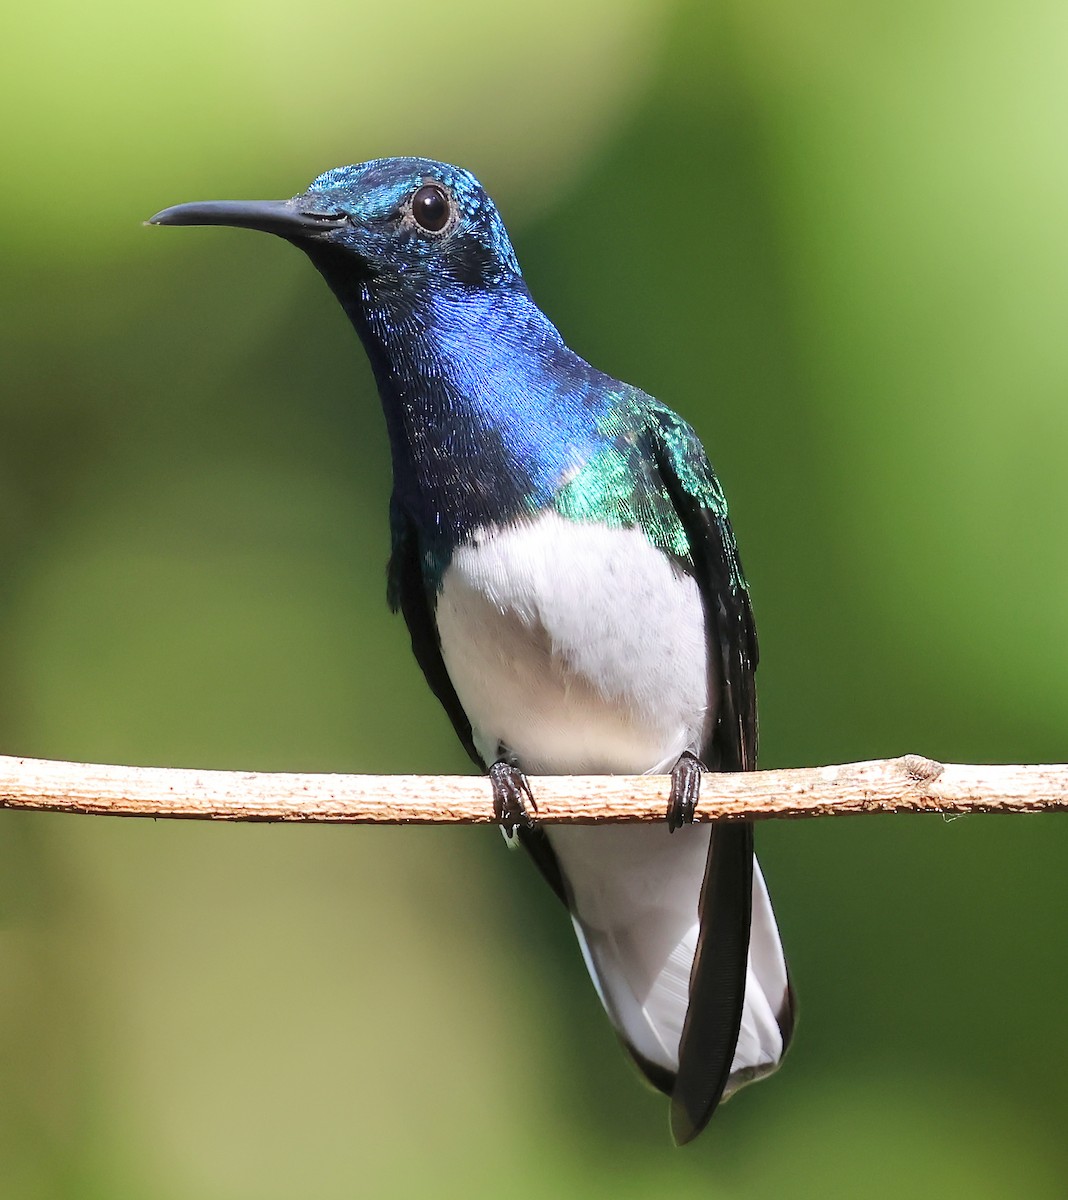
553,826,793,1142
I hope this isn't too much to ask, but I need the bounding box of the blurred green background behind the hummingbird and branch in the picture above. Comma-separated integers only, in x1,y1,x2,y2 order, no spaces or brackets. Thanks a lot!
0,0,1068,1200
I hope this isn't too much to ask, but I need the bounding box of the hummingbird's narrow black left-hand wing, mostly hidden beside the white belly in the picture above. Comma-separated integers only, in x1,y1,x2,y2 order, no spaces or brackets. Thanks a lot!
386,505,568,904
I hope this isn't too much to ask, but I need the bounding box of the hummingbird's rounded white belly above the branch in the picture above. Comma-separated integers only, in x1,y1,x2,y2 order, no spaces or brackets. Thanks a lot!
436,514,715,774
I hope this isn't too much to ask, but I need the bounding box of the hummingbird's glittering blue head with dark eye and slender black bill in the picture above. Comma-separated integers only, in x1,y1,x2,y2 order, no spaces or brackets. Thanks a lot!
149,158,520,289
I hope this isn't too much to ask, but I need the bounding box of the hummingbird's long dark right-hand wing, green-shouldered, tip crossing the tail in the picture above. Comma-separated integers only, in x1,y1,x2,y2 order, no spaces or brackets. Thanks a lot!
652,406,757,1145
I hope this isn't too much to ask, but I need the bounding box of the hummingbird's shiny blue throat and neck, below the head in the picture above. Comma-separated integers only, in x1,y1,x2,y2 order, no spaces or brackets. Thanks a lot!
303,256,623,552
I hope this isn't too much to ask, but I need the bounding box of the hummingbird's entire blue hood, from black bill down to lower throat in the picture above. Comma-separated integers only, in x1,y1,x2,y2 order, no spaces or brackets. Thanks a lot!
151,158,612,549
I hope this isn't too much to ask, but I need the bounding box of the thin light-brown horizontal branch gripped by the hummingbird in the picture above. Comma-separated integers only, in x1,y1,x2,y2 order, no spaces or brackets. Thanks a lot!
0,755,1068,824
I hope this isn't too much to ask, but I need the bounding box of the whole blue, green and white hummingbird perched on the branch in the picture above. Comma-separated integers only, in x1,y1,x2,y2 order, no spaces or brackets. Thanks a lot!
149,157,794,1145
